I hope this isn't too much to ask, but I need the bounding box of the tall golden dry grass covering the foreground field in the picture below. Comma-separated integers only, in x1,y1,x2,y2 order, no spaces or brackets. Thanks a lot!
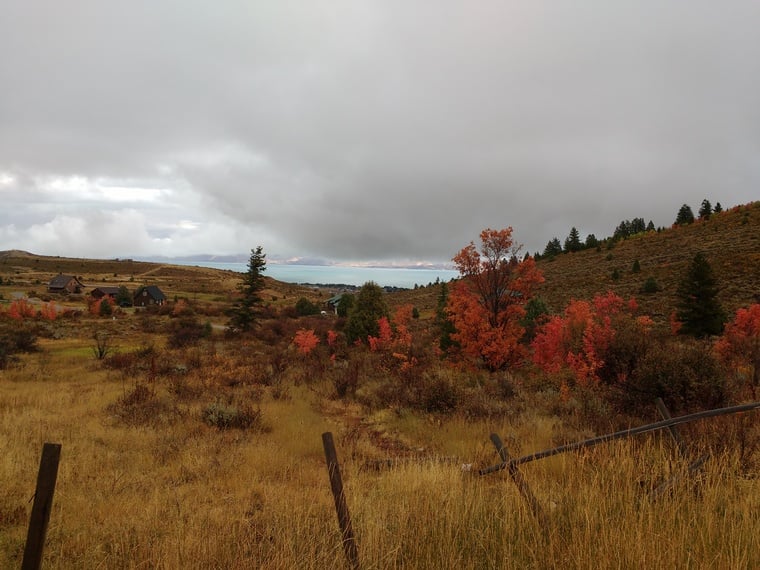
0,343,760,569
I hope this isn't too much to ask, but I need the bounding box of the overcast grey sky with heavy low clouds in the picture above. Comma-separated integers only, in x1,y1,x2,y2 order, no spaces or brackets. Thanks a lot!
0,0,760,263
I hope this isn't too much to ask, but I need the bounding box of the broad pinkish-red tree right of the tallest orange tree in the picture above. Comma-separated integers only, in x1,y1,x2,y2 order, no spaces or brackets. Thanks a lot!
531,292,653,385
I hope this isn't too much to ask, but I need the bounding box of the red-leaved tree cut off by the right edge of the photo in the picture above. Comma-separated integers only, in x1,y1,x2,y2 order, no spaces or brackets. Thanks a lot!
716,303,760,396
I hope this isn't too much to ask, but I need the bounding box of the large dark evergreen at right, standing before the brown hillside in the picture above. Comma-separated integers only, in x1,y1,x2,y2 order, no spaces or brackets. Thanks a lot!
676,252,726,338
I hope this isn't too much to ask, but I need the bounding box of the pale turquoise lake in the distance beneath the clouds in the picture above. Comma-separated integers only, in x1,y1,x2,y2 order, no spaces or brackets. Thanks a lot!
172,261,459,289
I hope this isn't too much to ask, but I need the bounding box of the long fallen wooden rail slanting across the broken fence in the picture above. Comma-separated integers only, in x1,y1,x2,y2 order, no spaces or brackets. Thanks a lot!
478,402,760,475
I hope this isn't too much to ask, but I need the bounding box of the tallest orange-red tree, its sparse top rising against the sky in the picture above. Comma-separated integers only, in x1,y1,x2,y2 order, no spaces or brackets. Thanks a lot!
447,227,544,370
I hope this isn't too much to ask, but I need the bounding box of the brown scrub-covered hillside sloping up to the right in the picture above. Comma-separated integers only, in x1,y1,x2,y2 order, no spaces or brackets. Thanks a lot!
538,202,760,318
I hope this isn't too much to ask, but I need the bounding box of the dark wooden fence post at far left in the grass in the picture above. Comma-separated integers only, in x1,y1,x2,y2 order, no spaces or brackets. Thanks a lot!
21,443,61,570
